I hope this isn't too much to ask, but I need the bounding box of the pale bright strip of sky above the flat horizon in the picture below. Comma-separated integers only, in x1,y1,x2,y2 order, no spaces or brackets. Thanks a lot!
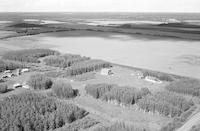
0,0,200,12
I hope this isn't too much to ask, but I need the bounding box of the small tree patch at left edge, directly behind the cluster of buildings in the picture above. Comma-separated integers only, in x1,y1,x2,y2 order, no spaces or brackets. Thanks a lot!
0,59,25,72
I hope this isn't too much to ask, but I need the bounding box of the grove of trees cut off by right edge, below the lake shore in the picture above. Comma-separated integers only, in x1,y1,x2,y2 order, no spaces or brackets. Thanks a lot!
166,78,200,97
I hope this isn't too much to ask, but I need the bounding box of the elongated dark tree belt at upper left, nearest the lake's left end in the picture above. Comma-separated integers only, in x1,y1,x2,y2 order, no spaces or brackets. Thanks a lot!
2,49,58,63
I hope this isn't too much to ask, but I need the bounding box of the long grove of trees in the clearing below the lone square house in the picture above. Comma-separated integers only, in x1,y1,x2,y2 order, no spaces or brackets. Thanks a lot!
85,84,150,105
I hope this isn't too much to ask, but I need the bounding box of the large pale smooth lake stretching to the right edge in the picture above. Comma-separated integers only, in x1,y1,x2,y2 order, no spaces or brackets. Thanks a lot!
33,31,200,78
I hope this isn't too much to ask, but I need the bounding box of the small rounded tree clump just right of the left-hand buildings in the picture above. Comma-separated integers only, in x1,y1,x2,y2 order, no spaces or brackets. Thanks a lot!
27,73,53,90
